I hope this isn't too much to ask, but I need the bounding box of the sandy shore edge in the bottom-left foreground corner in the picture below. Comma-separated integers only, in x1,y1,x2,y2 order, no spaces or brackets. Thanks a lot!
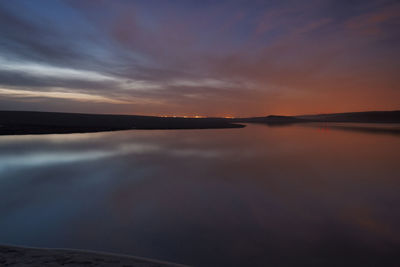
0,246,184,267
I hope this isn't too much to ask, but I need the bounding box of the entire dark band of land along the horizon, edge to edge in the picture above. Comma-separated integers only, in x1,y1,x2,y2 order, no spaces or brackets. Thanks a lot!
0,111,400,135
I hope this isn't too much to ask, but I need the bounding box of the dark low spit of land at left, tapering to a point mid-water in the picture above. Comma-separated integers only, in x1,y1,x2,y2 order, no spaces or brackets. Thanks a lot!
0,111,244,135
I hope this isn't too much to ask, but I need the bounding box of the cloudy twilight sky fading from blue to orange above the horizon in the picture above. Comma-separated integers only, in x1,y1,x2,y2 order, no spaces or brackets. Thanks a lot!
0,0,400,116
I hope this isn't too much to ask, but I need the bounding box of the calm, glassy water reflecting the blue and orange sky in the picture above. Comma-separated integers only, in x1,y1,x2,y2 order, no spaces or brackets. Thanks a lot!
0,125,400,266
